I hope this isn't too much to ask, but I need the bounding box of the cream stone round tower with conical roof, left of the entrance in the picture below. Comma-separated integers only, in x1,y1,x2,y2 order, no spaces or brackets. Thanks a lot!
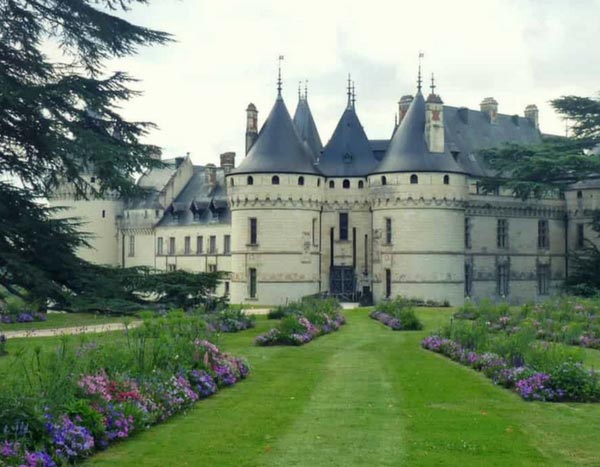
227,84,323,305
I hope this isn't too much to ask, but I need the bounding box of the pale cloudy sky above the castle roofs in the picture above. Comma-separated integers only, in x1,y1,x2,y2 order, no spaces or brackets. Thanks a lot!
107,0,600,164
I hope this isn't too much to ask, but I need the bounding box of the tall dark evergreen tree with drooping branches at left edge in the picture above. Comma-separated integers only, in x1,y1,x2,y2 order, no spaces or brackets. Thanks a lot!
0,0,171,308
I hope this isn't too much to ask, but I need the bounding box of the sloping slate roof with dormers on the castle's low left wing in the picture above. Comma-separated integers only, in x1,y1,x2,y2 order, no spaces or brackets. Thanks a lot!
158,166,231,226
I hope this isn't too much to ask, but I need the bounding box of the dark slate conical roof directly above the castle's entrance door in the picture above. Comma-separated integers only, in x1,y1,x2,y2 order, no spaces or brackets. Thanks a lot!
319,100,377,177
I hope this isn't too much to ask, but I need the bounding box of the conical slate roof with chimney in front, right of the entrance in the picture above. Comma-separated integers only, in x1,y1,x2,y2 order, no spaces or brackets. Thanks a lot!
372,91,464,173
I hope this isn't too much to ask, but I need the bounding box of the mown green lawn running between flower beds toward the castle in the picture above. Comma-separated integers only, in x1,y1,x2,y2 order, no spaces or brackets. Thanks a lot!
86,310,600,467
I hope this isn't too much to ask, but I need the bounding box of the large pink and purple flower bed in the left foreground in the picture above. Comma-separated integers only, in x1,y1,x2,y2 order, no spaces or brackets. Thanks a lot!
0,317,249,467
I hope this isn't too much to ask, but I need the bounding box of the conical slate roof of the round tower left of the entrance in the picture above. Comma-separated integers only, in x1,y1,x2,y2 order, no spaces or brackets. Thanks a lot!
232,95,319,175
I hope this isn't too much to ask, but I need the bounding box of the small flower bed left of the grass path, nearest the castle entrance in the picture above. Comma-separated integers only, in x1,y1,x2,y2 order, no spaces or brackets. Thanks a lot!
254,299,346,346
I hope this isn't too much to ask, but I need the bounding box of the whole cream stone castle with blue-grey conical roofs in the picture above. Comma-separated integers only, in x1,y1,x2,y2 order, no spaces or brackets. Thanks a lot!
50,71,598,305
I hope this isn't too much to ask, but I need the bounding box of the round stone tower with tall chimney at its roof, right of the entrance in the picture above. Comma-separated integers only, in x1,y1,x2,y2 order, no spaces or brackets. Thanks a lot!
369,84,467,305
